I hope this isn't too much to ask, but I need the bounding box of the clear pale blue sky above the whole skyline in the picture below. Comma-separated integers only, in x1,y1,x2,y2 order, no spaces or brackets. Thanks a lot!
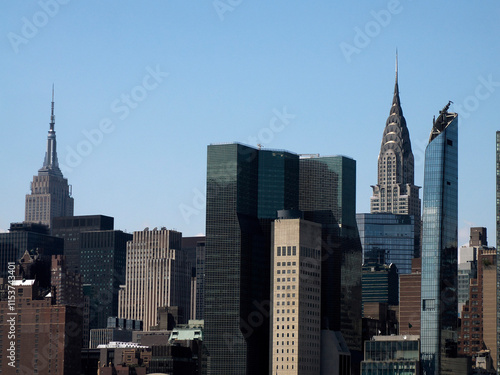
0,0,500,246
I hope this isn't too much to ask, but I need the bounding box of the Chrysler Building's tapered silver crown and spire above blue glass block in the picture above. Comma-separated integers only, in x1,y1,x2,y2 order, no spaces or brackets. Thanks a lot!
370,55,420,218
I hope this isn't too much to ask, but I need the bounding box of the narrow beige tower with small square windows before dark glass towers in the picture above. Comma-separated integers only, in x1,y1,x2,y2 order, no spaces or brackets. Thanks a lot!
270,219,321,375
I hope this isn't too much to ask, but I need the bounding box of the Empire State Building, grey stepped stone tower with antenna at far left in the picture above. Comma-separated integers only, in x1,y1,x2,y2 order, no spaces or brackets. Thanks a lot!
24,87,74,227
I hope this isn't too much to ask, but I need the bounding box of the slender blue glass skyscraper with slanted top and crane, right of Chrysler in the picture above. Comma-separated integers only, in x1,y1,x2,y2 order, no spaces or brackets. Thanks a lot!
420,103,458,375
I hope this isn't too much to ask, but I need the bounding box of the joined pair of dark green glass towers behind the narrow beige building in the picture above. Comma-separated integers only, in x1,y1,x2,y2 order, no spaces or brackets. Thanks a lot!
204,143,361,375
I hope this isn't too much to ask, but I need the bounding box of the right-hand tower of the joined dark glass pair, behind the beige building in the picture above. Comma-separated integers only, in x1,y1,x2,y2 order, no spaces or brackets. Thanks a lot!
299,156,362,356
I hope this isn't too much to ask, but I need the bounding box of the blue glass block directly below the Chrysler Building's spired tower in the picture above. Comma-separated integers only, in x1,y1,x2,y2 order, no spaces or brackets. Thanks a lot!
356,213,420,274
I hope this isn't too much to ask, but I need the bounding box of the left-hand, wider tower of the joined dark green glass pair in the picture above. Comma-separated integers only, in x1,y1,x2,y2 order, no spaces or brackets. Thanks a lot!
204,144,298,375
